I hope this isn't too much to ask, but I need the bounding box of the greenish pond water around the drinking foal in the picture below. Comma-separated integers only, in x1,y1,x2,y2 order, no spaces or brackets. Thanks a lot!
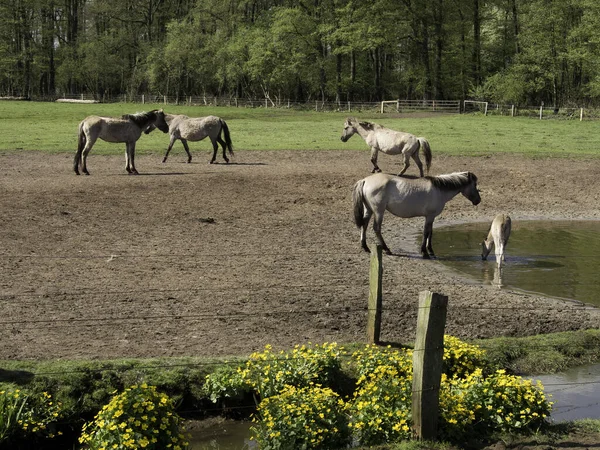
433,219,600,306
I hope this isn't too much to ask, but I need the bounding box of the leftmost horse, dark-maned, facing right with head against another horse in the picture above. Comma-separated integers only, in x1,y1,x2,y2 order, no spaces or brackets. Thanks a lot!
73,109,169,175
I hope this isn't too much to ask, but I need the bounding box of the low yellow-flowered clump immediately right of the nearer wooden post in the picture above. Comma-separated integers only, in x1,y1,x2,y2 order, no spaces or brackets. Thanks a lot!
440,369,552,439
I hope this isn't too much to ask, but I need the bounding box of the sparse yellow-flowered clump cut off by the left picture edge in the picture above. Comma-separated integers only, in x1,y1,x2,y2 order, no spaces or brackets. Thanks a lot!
0,388,61,443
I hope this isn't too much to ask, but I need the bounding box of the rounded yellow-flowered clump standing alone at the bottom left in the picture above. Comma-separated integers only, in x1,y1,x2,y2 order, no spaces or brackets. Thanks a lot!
79,384,188,450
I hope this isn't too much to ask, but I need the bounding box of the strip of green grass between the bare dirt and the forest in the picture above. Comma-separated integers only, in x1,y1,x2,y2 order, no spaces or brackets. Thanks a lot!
0,101,600,158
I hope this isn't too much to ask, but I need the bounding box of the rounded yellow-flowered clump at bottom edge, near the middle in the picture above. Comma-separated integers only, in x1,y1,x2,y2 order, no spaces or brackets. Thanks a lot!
252,383,350,450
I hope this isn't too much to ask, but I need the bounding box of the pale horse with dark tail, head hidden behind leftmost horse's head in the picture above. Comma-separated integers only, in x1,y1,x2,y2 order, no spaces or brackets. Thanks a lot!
144,114,233,164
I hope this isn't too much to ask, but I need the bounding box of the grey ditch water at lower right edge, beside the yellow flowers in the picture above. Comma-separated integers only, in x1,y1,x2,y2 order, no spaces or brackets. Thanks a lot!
532,364,600,422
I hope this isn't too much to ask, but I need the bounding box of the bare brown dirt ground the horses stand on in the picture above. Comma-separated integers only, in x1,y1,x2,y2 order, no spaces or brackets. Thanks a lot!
0,150,600,359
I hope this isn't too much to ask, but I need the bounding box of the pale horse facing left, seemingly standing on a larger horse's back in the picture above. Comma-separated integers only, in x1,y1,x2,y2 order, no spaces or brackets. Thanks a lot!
341,117,431,177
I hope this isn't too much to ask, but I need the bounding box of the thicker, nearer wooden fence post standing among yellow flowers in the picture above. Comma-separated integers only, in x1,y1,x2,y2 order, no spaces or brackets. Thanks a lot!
412,291,448,440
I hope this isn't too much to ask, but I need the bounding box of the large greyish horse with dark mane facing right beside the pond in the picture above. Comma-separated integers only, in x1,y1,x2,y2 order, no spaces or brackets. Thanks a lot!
352,172,481,259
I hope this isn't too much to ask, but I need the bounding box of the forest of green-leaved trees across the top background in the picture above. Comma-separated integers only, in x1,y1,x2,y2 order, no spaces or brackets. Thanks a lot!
0,0,600,107
